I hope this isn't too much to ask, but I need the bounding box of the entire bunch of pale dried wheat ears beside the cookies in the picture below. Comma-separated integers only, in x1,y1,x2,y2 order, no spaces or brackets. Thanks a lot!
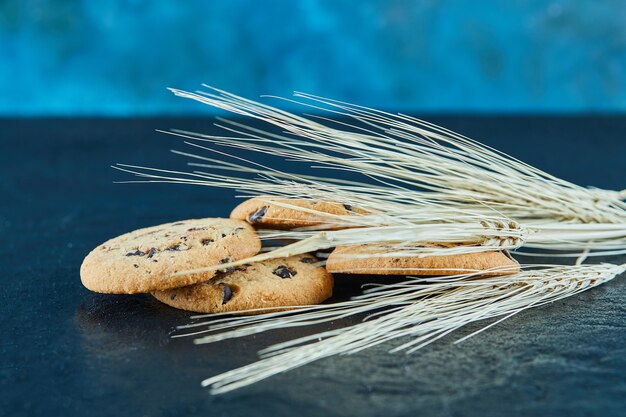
115,87,626,393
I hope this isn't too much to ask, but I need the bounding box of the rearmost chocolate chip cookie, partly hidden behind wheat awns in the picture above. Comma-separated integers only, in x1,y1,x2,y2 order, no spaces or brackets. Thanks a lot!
230,197,367,229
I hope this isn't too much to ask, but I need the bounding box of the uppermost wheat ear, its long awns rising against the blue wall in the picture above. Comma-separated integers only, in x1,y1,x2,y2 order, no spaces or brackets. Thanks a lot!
161,86,626,223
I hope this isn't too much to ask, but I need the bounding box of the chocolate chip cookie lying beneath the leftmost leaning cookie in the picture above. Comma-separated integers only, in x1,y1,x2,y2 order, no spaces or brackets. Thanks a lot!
153,255,333,314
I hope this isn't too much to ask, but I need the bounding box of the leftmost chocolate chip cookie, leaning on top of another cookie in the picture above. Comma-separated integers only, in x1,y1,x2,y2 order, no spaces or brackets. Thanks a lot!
80,218,261,294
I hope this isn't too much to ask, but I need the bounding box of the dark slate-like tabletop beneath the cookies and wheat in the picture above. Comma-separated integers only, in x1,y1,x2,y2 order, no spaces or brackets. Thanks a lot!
0,117,626,416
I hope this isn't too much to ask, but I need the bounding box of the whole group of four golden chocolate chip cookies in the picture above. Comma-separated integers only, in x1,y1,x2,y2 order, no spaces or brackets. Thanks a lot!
80,198,519,313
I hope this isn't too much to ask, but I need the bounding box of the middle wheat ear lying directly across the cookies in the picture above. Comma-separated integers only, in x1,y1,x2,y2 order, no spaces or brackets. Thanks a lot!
146,217,626,276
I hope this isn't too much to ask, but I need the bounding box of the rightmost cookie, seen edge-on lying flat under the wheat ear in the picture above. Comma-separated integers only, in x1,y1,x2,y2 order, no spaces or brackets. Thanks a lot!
326,245,520,276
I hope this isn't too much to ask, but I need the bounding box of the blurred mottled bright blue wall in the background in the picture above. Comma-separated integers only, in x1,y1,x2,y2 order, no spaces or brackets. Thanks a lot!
0,0,626,115
